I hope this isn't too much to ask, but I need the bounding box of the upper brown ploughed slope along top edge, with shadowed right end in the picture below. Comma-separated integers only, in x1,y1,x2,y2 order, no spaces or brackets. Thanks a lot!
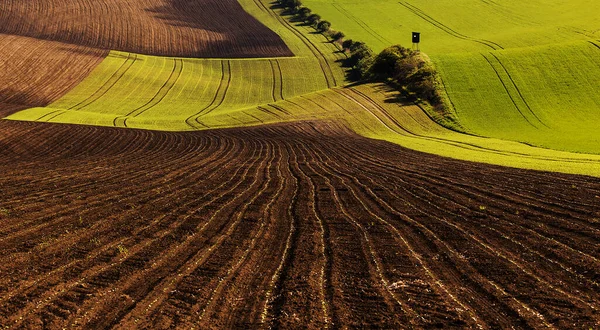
0,0,293,57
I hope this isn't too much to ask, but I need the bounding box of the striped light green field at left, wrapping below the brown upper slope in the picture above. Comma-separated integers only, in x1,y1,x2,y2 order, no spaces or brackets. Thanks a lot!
8,0,345,131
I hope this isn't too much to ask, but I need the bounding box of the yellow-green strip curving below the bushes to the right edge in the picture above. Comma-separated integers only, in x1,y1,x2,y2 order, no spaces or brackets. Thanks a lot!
179,84,600,176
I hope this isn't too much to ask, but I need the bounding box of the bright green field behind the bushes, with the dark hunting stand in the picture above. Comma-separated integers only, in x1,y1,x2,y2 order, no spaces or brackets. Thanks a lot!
304,0,600,154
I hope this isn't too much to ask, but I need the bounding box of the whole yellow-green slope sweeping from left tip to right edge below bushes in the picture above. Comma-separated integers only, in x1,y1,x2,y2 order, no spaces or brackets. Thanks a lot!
4,2,600,176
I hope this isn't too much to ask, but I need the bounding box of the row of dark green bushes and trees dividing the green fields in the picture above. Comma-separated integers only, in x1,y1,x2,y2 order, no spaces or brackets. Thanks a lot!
278,0,443,106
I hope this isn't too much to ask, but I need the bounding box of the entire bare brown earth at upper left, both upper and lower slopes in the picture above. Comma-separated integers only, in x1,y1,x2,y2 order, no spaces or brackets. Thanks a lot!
0,0,293,116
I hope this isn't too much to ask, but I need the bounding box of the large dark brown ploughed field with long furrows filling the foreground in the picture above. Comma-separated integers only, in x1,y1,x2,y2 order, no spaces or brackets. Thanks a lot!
0,121,600,329
